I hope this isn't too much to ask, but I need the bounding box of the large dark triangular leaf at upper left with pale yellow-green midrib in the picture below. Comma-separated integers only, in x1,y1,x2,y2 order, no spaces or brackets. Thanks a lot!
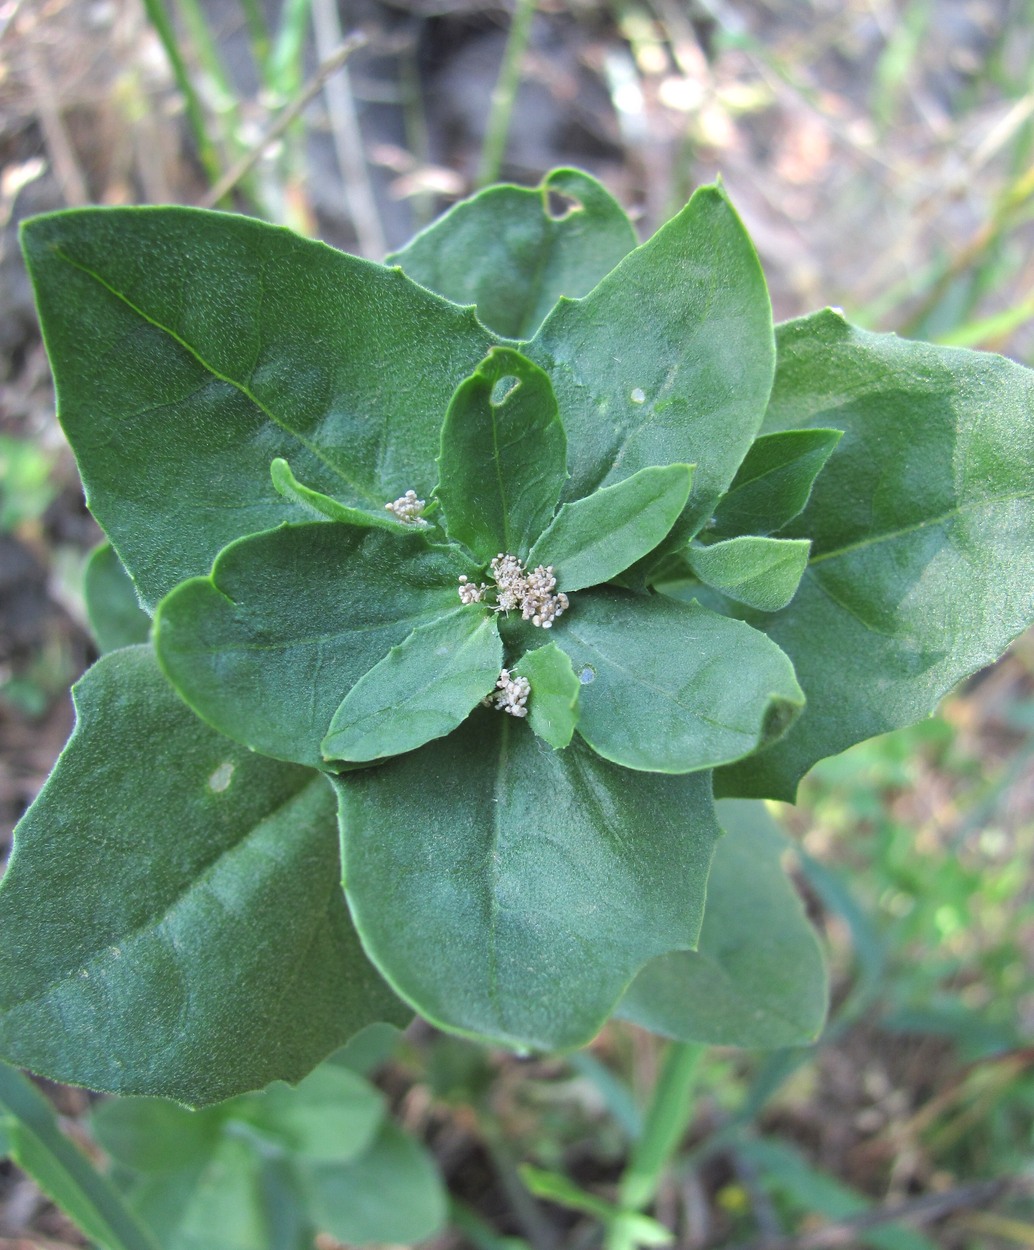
23,208,494,606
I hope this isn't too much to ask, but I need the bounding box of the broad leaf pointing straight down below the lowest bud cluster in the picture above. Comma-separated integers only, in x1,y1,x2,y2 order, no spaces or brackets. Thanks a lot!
335,709,718,1050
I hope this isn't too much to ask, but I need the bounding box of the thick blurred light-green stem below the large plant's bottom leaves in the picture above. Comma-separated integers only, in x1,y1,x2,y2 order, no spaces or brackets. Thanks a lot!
618,1041,704,1211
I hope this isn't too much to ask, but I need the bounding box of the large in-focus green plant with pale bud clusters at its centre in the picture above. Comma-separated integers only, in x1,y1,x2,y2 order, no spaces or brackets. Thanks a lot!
0,170,1034,1244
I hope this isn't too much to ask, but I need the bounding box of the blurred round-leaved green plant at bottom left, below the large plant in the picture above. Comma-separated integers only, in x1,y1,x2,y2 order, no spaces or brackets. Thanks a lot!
91,1030,445,1250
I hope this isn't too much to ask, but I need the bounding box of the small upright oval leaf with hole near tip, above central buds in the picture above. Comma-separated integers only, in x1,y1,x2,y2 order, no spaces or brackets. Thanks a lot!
435,348,568,561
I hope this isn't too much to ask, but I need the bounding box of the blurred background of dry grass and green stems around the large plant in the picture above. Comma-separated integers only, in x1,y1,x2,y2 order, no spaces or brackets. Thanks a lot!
0,0,1034,1250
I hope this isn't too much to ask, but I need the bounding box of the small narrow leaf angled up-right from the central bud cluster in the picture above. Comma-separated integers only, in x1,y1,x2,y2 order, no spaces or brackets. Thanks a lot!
528,465,693,591
